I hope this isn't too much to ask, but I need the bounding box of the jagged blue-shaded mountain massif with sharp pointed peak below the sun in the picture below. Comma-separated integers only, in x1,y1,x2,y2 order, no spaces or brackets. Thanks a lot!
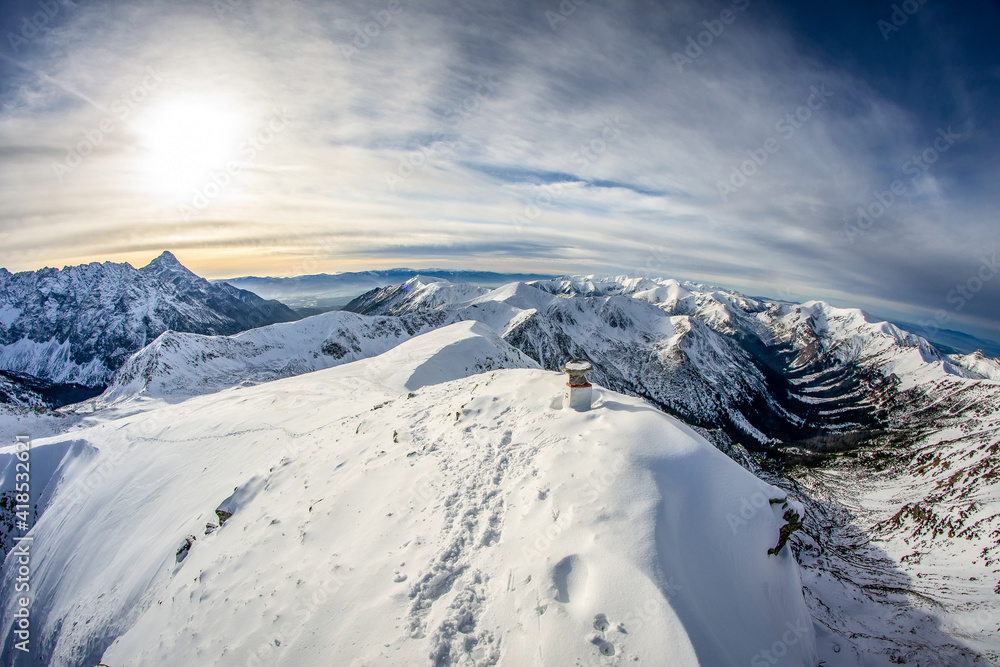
0,252,298,387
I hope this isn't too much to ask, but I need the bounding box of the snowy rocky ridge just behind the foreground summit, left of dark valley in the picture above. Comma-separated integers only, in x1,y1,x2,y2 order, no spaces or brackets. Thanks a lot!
121,276,780,441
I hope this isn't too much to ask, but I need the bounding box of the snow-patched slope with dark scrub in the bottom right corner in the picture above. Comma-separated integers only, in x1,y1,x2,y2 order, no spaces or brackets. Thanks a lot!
773,378,1000,667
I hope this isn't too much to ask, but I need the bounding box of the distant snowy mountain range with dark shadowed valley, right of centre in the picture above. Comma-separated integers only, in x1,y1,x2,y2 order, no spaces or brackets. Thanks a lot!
346,276,1000,450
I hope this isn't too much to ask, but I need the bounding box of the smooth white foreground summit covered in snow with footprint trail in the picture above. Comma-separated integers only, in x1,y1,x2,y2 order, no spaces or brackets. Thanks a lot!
0,323,817,667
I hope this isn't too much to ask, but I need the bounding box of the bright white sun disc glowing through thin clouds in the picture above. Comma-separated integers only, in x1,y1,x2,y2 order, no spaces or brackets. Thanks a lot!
136,95,246,202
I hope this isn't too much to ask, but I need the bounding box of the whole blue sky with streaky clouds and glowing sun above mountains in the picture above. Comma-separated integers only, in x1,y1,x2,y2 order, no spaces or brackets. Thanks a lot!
0,0,1000,339
